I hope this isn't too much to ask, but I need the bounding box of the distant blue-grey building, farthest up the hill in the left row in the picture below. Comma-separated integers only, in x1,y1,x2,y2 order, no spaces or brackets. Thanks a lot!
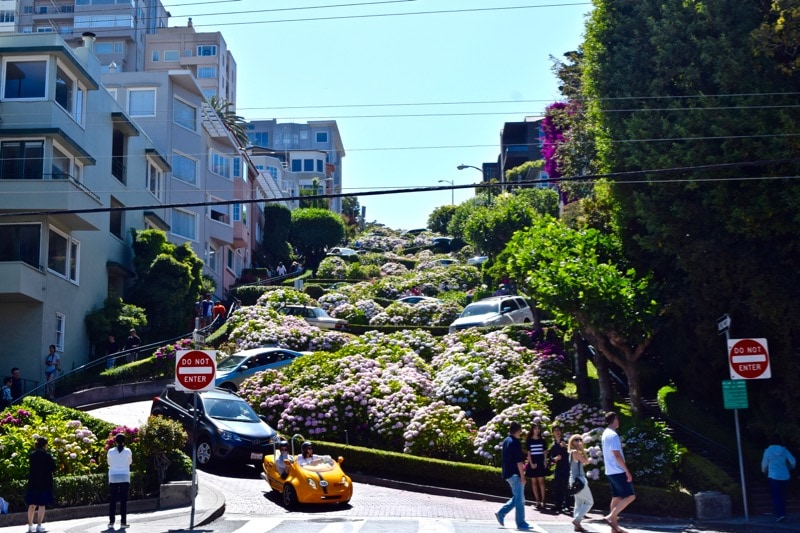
247,119,346,213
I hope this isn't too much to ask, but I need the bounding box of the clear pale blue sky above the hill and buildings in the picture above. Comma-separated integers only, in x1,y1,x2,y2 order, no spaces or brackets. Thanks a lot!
164,0,591,229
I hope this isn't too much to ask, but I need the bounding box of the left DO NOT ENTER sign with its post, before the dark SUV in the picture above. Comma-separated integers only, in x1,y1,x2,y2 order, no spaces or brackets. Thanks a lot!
175,350,217,530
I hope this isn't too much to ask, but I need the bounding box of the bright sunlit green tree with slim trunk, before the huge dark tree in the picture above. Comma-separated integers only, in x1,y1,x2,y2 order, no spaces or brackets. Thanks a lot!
497,216,660,414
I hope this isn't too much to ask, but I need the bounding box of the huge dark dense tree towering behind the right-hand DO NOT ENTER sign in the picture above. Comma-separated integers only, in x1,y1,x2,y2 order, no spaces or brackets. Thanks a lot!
582,0,800,432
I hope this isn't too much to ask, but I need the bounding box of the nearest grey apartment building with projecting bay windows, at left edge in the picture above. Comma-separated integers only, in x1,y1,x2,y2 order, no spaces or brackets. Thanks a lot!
0,33,170,382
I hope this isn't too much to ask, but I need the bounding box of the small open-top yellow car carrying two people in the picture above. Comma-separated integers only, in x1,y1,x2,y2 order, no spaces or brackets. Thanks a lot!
261,441,353,508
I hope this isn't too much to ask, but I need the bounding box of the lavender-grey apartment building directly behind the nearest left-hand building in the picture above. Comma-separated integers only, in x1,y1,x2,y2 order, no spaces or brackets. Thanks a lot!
101,70,247,298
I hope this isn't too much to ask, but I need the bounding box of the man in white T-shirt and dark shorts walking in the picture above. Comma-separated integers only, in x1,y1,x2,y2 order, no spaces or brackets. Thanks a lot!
601,411,636,533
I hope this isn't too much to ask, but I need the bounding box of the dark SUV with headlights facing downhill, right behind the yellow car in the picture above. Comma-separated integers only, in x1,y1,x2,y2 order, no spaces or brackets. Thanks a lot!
150,384,277,465
